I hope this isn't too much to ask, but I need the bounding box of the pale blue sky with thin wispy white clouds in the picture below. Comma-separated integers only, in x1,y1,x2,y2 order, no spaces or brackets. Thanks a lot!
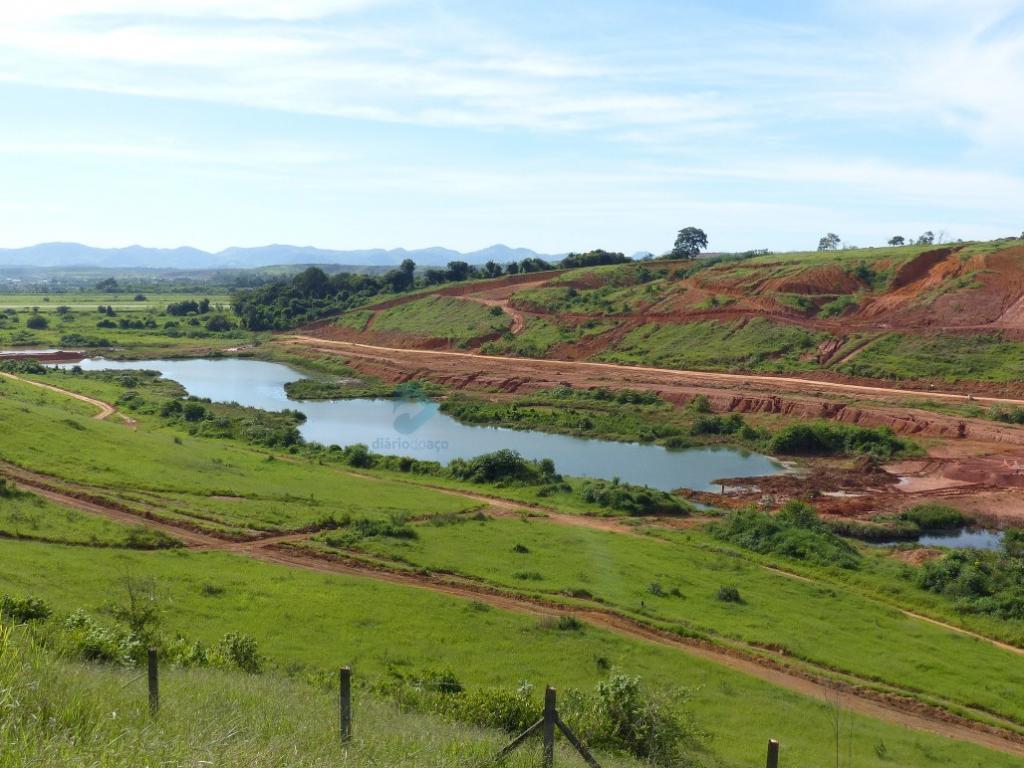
0,0,1024,254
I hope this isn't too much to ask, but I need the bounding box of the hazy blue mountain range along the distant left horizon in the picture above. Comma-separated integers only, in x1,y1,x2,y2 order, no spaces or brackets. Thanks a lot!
0,243,564,269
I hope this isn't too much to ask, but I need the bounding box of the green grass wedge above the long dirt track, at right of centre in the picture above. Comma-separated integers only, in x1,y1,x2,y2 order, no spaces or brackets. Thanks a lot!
301,518,1024,725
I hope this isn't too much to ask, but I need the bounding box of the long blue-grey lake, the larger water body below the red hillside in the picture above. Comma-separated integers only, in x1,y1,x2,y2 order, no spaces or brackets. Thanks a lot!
62,357,782,490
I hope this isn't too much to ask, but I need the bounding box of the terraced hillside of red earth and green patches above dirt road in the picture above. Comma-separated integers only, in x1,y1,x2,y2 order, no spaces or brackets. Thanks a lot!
306,240,1024,391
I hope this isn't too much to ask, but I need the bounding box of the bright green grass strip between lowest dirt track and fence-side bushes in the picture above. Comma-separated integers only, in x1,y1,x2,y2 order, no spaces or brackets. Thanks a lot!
0,542,1017,768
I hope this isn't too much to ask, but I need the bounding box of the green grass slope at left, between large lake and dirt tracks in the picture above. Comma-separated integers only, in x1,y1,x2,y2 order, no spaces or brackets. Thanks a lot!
0,376,477,532
